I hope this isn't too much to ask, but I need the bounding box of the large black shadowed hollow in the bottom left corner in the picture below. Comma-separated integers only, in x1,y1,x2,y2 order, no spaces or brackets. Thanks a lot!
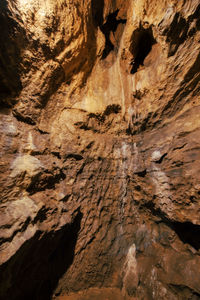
0,211,83,300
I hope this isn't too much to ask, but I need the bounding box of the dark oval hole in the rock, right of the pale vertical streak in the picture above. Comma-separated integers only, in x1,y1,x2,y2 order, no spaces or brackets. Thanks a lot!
130,27,156,74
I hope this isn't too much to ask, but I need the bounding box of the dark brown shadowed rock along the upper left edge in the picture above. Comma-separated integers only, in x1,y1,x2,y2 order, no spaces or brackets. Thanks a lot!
0,0,26,109
